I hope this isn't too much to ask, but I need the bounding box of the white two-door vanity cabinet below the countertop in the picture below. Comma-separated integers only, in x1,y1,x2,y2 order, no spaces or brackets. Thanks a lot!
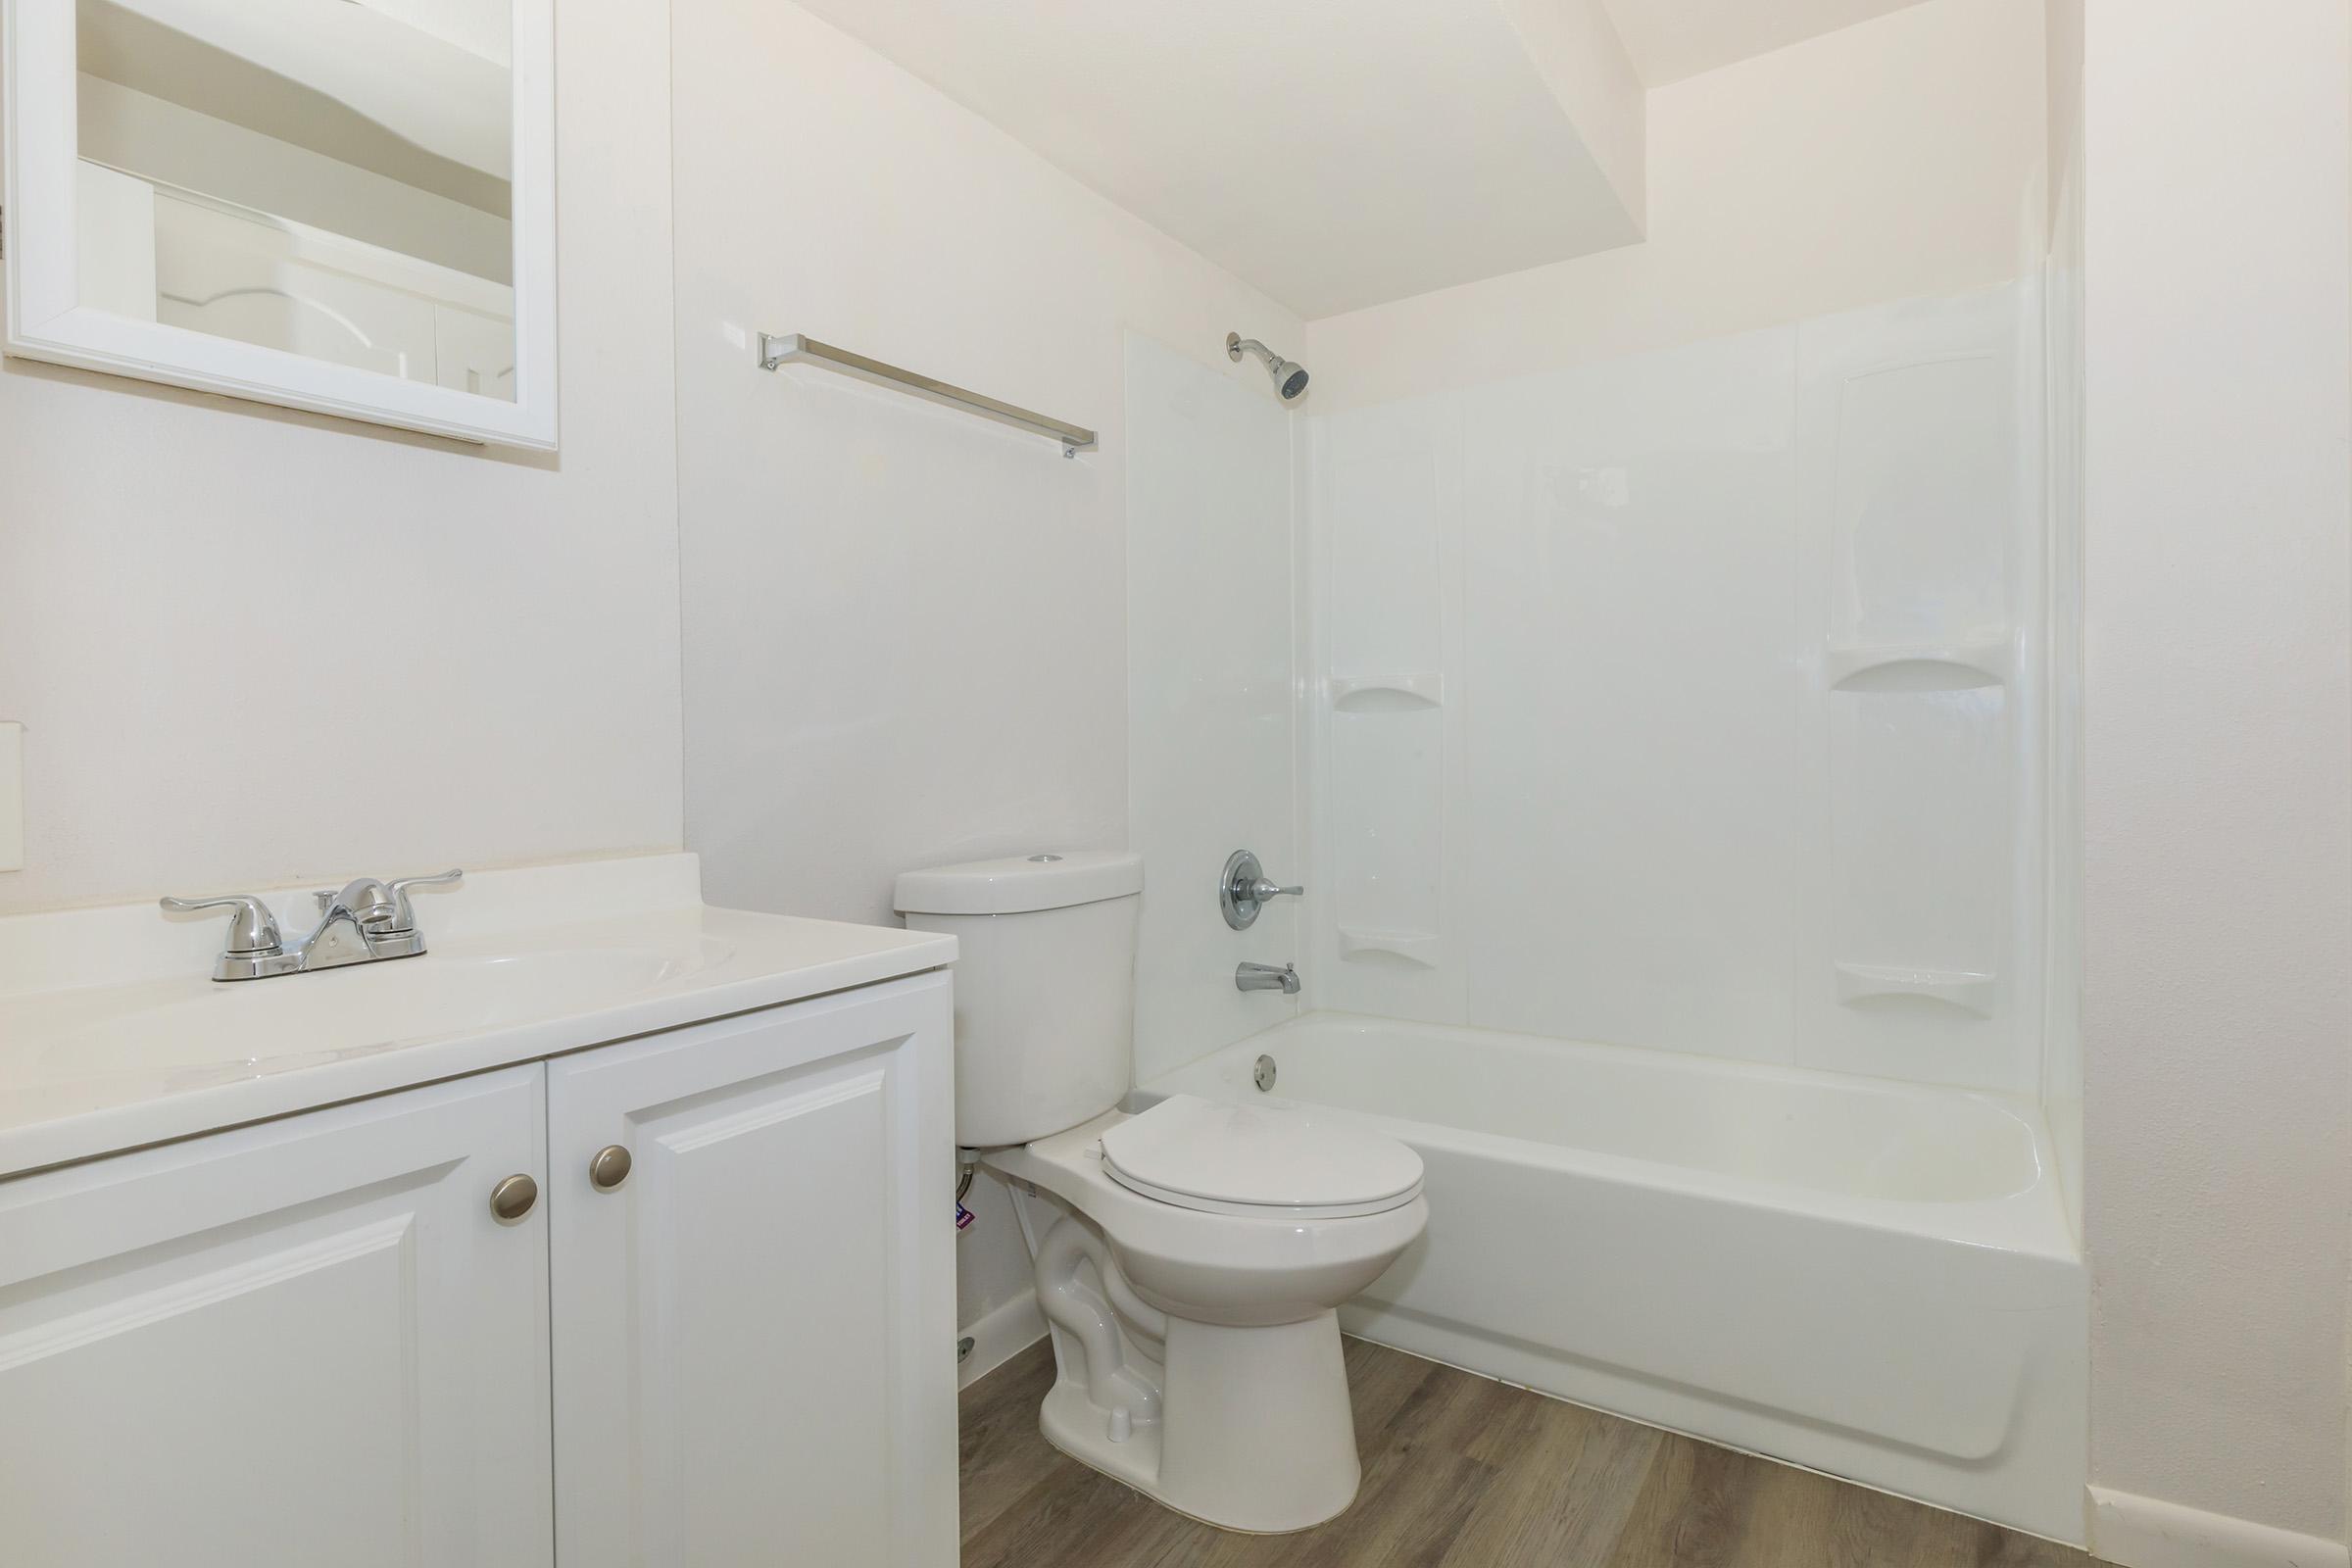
0,971,957,1568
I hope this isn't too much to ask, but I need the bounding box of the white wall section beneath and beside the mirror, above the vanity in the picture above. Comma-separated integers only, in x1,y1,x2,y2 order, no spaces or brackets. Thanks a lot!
0,0,680,909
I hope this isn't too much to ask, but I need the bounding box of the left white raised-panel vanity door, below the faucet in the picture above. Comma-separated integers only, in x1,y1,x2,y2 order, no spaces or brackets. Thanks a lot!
0,1067,553,1568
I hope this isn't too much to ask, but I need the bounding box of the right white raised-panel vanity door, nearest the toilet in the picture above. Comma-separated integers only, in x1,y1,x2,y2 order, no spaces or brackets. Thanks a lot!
548,976,957,1568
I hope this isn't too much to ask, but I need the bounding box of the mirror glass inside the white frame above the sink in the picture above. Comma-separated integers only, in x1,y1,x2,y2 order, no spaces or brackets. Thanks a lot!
75,0,515,402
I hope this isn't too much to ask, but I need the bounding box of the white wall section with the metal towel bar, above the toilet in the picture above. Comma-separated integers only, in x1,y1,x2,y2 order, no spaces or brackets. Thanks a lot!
675,5,1298,1324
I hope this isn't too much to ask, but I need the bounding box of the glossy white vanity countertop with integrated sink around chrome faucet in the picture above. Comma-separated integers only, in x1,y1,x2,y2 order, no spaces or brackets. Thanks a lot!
0,856,955,1178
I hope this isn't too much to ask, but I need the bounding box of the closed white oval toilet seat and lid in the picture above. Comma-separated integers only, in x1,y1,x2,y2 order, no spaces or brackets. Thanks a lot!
1103,1096,1421,1220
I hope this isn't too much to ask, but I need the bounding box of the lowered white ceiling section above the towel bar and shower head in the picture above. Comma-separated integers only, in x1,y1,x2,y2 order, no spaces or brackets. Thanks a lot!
780,0,1640,318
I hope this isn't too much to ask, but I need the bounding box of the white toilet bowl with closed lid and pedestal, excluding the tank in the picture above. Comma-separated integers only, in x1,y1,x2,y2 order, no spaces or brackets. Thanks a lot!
986,1096,1430,1533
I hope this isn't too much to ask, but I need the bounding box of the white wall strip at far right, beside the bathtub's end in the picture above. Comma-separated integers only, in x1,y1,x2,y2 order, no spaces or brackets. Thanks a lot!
2083,0,2352,1563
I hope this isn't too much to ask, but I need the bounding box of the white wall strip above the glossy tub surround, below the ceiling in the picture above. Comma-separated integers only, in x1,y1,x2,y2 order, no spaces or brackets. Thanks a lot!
1298,0,2046,414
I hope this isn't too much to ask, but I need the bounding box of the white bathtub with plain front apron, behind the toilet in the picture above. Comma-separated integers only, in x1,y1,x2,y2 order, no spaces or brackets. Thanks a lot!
1139,1013,2088,1543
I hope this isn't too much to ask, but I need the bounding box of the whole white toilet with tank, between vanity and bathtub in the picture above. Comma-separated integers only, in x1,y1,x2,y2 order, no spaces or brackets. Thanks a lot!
896,851,1430,1533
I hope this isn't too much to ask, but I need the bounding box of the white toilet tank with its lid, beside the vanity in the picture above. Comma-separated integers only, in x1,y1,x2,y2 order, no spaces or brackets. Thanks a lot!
896,849,1143,1150
